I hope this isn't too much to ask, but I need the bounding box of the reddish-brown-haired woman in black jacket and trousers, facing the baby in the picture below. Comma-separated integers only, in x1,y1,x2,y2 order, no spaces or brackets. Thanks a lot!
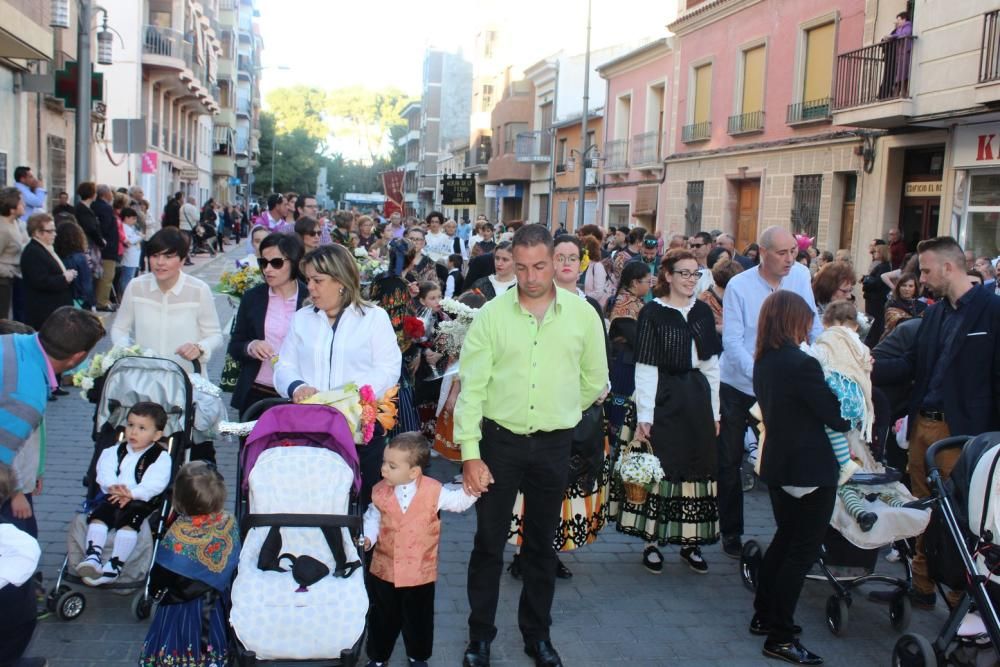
750,290,850,665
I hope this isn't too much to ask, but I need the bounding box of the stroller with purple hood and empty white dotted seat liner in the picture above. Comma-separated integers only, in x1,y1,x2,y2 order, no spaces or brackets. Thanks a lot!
229,404,368,667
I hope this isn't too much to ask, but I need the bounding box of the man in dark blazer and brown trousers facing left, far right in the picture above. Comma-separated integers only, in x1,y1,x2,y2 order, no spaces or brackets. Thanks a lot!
872,236,1000,608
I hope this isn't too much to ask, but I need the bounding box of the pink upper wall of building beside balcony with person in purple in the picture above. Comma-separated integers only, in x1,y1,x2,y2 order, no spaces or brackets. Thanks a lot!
672,0,865,153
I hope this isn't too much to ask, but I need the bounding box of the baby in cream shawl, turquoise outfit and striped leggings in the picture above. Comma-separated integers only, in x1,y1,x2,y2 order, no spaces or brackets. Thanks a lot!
807,301,913,533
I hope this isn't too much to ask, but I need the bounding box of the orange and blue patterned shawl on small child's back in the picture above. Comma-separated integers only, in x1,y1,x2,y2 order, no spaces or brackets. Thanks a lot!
156,512,240,591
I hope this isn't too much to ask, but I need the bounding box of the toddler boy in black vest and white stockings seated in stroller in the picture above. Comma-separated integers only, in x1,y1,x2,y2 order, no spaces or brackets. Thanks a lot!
76,401,172,586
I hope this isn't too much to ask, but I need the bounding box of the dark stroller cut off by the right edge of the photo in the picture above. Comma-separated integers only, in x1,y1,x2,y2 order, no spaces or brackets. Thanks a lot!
892,432,1000,667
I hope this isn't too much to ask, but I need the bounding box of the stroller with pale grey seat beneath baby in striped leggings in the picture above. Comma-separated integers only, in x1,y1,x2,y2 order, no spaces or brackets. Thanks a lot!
740,434,930,636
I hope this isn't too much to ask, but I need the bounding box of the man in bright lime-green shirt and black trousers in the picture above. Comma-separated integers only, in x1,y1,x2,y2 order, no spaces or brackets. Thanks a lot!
454,225,608,667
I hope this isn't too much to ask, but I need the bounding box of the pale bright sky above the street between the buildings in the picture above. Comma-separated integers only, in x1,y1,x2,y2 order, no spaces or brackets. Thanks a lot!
258,0,676,107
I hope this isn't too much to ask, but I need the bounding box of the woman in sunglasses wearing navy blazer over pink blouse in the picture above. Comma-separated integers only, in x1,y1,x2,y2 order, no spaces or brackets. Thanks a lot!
229,234,306,412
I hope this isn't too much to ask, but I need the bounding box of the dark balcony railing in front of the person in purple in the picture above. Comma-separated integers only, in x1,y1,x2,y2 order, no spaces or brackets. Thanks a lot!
833,37,915,110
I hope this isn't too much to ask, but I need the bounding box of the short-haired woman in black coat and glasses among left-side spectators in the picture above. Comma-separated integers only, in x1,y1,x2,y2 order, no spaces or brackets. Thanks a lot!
21,213,76,330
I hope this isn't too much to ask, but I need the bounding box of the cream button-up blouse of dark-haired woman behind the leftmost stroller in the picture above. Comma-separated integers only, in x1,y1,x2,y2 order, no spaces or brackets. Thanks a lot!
111,272,222,371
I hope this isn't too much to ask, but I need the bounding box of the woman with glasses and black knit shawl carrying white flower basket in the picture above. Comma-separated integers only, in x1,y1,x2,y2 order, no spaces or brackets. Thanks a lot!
610,249,722,574
